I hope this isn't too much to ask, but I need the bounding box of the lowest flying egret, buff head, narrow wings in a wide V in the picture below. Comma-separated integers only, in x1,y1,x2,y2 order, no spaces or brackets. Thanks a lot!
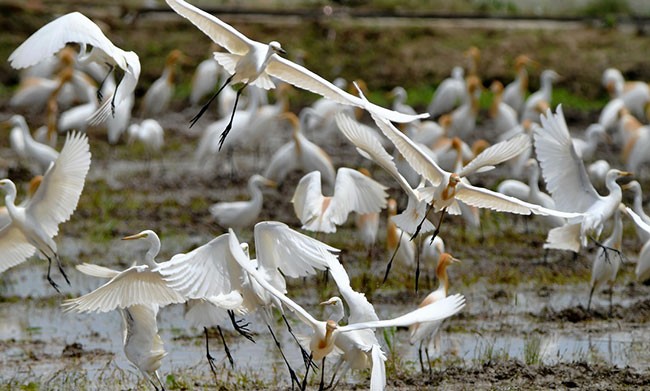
229,229,465,390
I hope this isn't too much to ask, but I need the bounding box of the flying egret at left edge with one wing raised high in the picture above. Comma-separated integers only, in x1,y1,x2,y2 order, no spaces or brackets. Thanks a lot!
0,132,90,291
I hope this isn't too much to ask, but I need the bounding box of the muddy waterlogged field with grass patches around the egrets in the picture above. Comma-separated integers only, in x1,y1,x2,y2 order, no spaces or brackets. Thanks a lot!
0,1,650,390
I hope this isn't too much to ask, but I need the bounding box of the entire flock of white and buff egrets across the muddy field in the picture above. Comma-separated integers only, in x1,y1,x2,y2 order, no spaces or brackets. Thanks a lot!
0,0,650,390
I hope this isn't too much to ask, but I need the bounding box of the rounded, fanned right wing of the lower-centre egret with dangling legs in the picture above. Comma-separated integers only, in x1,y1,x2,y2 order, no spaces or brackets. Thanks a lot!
254,221,339,289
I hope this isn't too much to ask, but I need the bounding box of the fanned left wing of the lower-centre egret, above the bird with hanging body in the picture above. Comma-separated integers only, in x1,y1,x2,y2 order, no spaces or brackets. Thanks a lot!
154,234,243,299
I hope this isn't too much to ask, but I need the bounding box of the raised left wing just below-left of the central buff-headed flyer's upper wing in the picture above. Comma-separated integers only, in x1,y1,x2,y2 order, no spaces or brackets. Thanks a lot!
336,113,417,198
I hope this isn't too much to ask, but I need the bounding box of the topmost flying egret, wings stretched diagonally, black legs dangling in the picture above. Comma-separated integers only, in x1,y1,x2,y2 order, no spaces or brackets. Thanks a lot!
166,0,429,149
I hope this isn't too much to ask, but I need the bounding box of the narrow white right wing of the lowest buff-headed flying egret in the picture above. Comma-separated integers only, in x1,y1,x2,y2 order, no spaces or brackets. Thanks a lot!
338,294,465,333
